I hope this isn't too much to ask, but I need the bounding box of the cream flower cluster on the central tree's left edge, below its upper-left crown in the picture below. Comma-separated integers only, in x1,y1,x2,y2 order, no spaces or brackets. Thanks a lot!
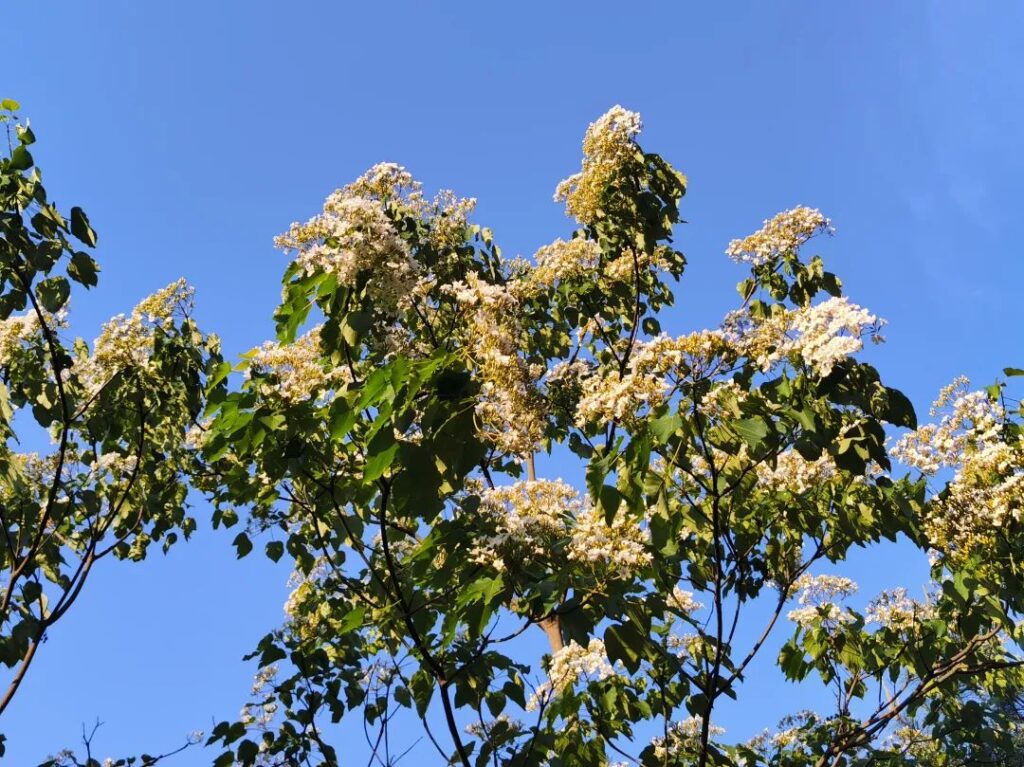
247,325,352,402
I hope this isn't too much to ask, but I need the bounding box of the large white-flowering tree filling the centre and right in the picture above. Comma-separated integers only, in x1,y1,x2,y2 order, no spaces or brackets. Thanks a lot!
199,106,1024,767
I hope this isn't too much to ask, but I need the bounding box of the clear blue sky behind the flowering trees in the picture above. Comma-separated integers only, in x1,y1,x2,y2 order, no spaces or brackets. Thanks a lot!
0,0,1024,765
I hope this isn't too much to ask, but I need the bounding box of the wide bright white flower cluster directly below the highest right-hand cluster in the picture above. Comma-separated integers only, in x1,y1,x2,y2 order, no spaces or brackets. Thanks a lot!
723,297,885,376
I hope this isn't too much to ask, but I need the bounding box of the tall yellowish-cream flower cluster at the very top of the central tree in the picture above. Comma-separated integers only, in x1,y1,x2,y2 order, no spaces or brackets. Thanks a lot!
555,104,642,224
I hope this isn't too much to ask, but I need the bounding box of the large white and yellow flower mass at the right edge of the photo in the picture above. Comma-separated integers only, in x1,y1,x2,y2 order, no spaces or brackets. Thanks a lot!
892,378,1024,554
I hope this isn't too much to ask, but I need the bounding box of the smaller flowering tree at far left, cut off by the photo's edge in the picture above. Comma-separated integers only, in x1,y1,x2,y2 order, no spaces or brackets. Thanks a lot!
0,100,218,755
